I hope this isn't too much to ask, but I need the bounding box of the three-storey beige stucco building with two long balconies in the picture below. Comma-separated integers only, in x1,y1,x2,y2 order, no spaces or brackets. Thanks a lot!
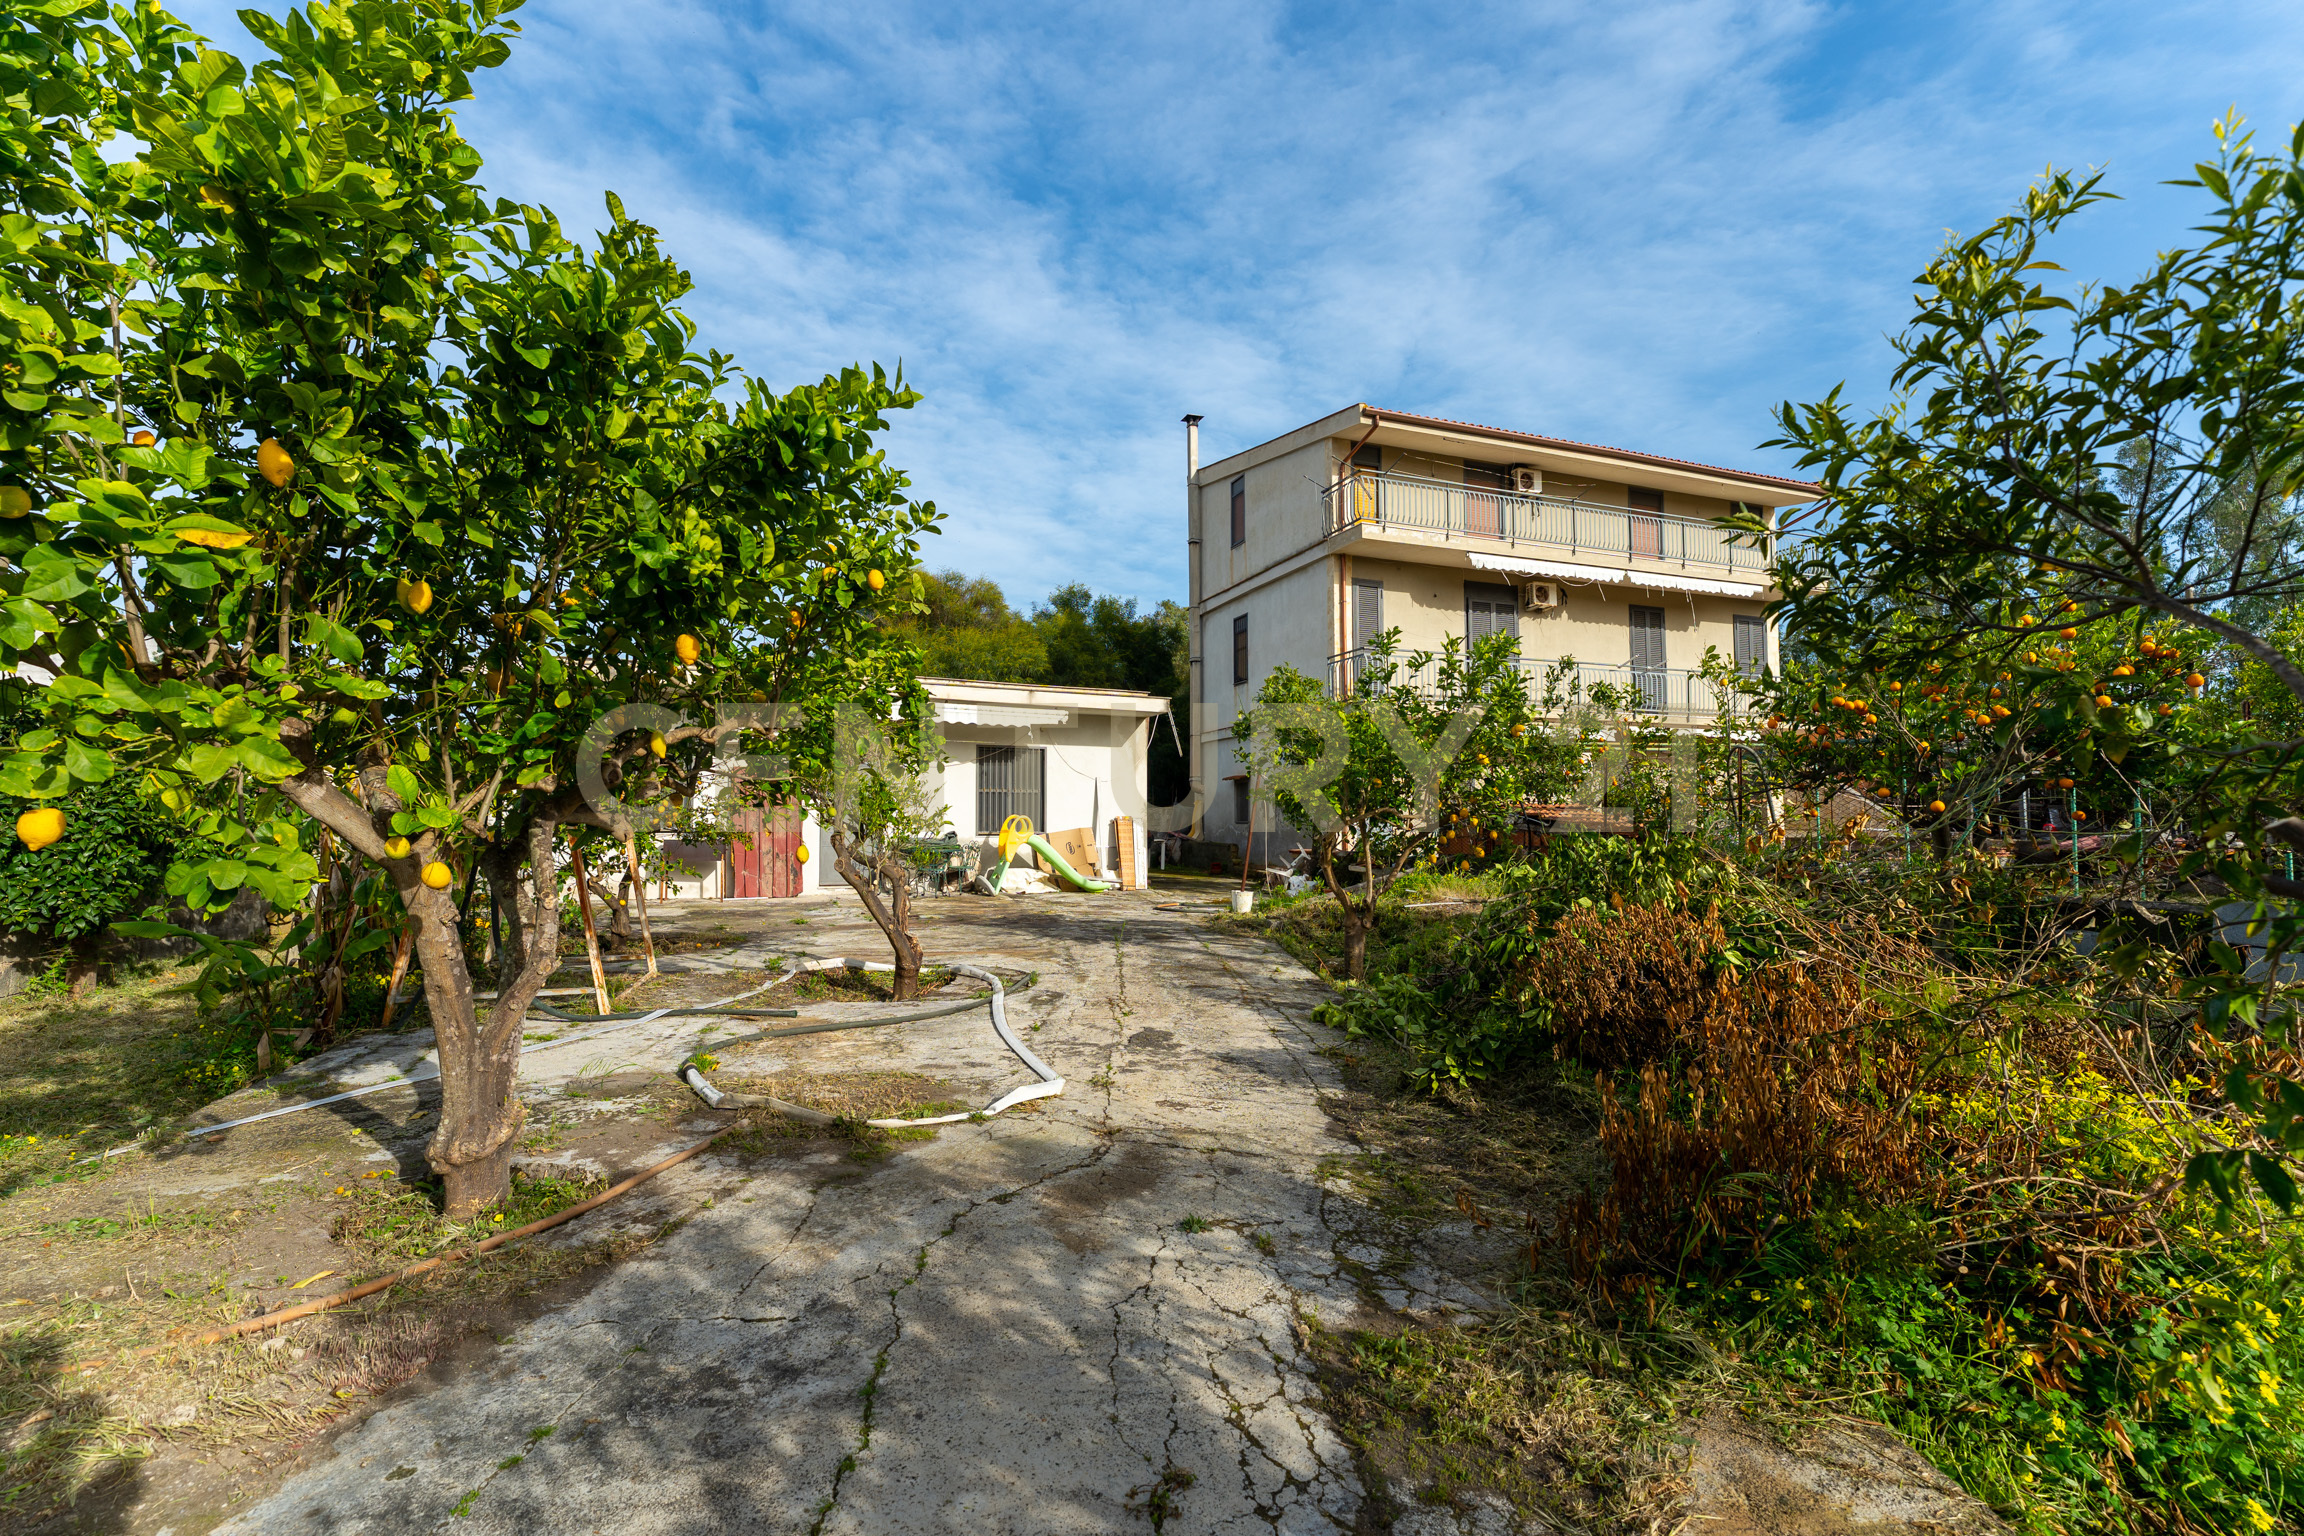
1184,405,1816,838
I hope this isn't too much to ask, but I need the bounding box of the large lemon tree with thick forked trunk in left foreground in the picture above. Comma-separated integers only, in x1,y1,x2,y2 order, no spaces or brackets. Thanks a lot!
0,0,935,1216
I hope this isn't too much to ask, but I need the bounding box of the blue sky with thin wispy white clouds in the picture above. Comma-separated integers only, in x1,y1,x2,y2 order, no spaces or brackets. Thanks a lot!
180,0,2304,603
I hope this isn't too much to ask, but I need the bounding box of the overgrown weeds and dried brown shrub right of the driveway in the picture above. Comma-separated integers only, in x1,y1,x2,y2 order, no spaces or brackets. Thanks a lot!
1290,838,2304,1534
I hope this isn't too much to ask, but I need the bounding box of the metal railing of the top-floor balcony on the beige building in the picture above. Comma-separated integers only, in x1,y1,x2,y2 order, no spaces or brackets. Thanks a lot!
1322,470,1769,578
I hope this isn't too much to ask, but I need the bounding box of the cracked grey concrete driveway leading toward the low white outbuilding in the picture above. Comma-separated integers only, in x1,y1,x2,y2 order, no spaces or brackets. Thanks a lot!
221,896,1470,1536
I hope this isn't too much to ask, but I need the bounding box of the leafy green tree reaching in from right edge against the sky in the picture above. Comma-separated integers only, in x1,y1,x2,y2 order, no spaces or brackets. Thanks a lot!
1741,122,2304,1207
